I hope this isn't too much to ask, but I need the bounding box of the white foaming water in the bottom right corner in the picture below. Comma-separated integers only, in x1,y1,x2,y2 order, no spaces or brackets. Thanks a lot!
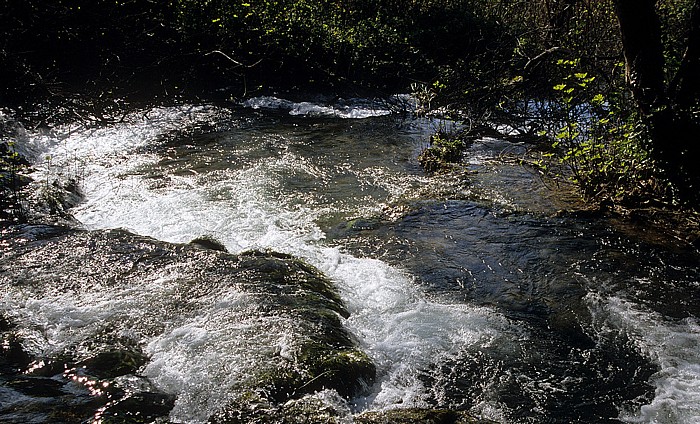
586,294,700,424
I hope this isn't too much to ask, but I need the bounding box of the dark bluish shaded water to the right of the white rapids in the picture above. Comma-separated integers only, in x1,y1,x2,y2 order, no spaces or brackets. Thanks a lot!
330,195,700,422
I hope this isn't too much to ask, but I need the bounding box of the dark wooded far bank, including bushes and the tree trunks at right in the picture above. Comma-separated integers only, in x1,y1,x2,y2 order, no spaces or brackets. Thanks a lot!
0,0,700,208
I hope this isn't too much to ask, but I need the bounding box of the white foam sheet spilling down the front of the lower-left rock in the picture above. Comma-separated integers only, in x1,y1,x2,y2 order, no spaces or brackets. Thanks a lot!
143,293,302,423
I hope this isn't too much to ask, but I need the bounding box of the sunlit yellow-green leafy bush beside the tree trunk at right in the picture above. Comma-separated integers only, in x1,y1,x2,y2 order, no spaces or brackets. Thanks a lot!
540,60,668,206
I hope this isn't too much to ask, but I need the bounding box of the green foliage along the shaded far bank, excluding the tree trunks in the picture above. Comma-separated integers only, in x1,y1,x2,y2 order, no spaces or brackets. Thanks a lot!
0,0,697,213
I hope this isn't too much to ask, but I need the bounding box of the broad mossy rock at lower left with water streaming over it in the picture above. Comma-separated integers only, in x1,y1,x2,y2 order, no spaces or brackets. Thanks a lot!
0,226,376,422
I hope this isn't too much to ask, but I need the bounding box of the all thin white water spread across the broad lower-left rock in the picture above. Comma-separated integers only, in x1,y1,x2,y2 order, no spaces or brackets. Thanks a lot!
0,267,326,423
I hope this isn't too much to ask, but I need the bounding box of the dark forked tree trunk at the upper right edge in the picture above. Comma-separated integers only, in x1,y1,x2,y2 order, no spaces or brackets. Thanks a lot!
615,0,700,207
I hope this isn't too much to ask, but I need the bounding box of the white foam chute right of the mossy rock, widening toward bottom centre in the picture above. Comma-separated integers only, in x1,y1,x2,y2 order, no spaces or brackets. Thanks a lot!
317,254,522,409
